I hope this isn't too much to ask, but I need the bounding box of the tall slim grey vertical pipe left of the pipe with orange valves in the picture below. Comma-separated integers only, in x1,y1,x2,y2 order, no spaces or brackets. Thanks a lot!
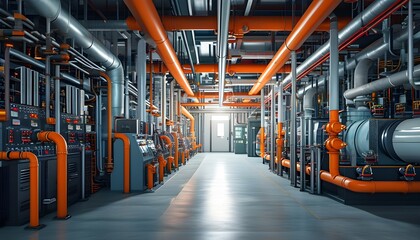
290,51,297,187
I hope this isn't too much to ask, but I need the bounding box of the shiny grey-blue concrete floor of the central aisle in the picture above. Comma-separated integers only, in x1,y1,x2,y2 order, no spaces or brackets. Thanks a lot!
0,153,420,240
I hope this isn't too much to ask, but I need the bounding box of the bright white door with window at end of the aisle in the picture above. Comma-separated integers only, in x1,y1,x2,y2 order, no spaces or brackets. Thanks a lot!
210,116,230,152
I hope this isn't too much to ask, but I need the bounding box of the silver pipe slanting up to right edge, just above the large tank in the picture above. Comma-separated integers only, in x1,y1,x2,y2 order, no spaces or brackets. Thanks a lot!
344,65,420,99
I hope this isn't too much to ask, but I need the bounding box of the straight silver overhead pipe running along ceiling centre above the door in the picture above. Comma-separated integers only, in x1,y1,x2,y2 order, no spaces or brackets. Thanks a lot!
217,0,230,107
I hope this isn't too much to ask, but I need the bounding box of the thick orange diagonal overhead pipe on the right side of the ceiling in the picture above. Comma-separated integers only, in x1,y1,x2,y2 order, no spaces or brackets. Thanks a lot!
249,0,341,95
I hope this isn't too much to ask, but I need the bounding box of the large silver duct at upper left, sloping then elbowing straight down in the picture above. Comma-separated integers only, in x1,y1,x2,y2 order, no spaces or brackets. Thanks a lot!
26,0,124,116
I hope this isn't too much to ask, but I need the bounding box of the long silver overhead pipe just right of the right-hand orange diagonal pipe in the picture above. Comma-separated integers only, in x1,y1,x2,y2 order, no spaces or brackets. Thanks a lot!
284,0,395,85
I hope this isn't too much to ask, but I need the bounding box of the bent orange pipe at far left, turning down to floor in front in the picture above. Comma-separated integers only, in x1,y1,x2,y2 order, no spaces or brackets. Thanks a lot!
0,152,42,228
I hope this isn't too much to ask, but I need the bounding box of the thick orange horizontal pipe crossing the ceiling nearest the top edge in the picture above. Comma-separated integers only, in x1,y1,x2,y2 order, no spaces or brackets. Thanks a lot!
126,16,349,33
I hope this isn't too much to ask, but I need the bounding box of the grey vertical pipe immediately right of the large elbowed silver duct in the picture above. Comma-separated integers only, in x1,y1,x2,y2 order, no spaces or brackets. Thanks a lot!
136,38,147,122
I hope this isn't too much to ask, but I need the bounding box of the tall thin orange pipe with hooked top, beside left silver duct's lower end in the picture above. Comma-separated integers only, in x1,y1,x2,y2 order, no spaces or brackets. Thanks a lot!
99,72,114,173
